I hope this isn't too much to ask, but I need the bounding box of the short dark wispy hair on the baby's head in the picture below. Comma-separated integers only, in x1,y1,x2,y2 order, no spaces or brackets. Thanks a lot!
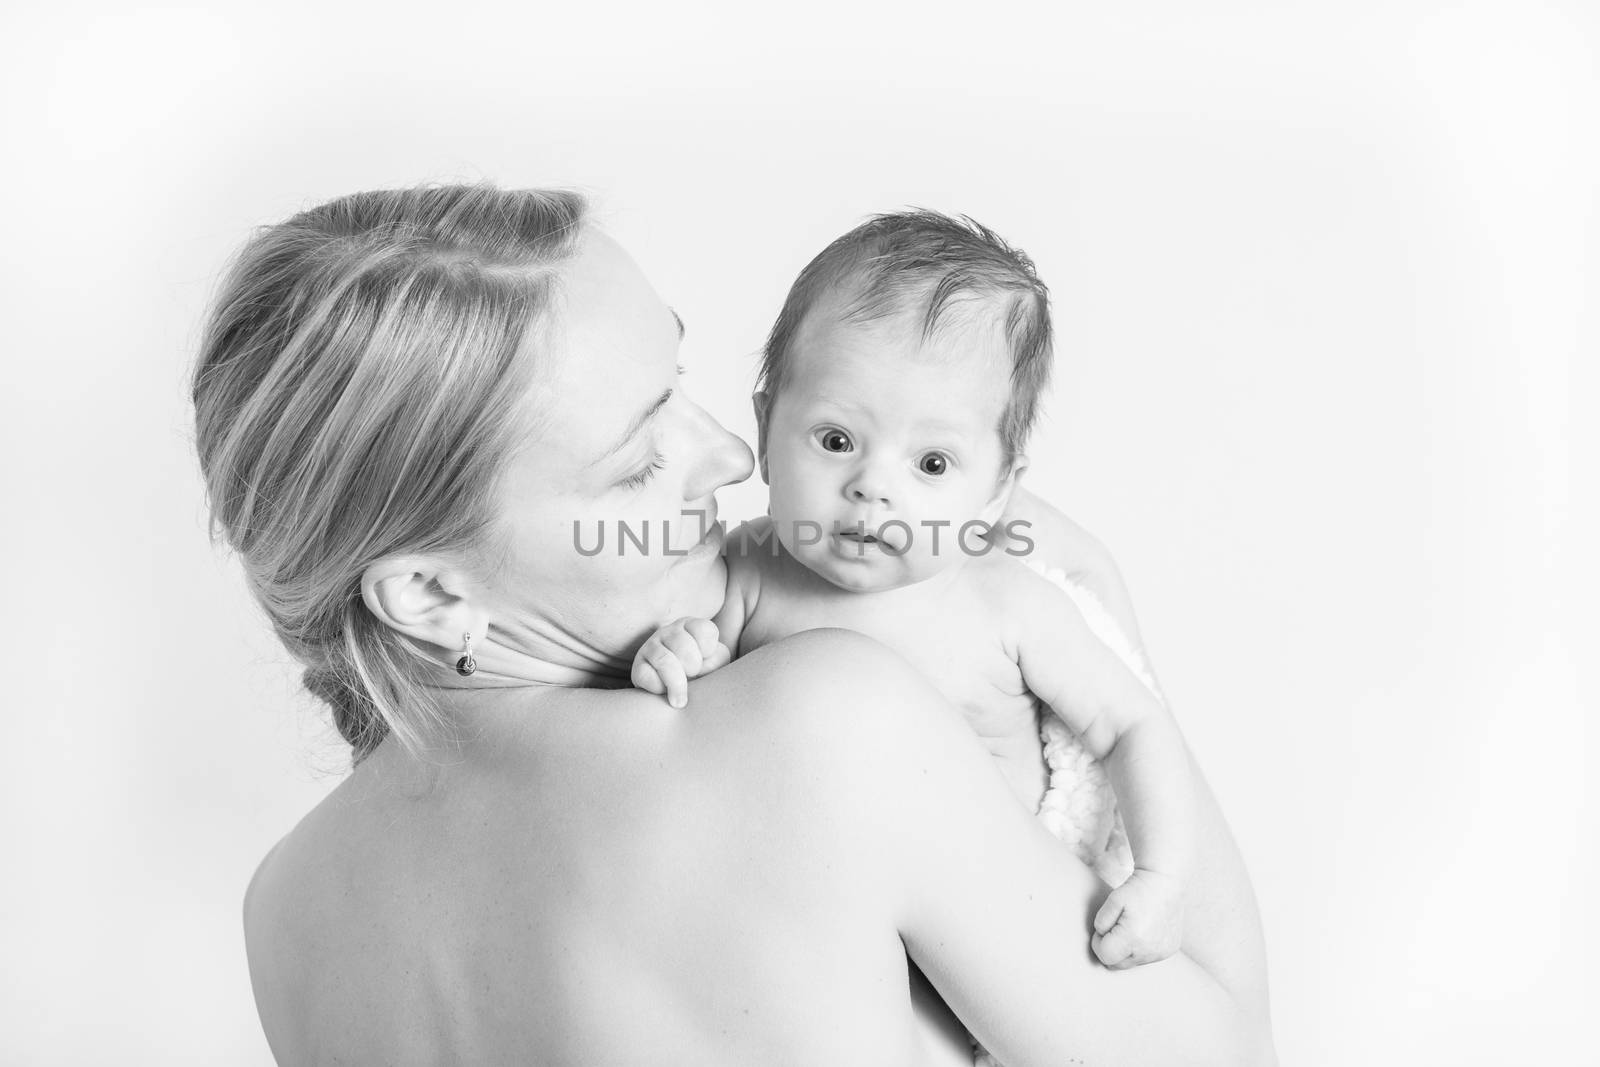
758,208,1051,466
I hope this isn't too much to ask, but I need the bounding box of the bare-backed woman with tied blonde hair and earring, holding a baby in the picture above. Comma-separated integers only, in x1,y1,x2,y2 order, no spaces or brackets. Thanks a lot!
194,187,1270,1067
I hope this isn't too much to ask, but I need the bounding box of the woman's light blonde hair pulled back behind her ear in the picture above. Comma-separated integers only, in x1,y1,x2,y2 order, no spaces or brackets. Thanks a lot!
194,186,584,761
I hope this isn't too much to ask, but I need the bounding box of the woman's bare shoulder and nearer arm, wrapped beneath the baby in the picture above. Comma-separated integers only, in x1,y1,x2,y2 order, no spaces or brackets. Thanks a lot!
782,632,1270,1067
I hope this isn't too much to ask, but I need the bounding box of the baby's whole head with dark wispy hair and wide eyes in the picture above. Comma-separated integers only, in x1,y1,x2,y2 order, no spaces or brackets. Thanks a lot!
755,211,1051,592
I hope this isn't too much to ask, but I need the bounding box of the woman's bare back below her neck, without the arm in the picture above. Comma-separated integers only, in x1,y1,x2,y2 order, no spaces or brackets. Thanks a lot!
245,643,922,1064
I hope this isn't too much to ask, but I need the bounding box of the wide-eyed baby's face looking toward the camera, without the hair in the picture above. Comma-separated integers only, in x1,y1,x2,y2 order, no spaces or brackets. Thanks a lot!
762,307,1014,592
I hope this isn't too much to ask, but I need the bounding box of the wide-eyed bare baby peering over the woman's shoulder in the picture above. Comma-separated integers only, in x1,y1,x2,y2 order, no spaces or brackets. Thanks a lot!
632,211,1194,968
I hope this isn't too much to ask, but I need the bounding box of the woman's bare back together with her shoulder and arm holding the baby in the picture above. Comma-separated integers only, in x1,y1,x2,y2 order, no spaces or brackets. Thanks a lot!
245,632,1270,1067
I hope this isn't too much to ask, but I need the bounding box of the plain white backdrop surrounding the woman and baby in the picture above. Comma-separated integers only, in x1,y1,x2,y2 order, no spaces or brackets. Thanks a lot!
0,0,1600,1065
